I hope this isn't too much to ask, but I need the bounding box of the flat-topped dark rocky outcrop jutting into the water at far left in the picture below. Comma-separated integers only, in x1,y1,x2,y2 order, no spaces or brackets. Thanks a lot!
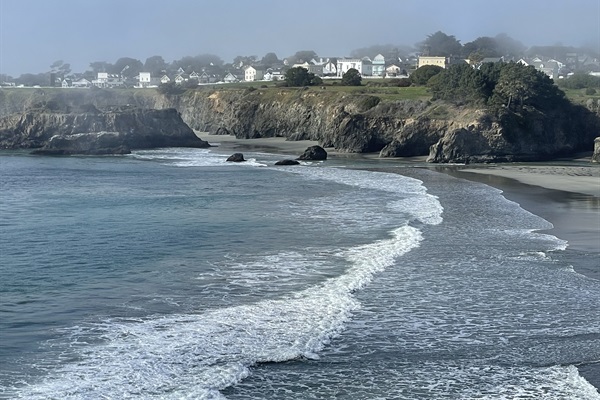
0,107,210,154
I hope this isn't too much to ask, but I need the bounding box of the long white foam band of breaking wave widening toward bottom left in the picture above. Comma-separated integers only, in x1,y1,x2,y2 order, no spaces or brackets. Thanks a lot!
11,226,422,399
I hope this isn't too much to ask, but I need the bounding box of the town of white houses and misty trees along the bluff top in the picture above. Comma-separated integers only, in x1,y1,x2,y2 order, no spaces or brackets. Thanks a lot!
0,32,600,88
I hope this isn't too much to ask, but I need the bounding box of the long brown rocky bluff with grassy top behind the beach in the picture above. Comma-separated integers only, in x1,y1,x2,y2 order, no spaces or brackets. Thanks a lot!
0,86,600,163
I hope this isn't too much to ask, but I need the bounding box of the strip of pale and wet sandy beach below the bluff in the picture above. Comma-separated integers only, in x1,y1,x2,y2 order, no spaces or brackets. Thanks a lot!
196,132,600,266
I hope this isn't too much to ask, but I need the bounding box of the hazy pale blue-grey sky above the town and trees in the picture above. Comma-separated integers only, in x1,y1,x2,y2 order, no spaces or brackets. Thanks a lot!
0,0,600,77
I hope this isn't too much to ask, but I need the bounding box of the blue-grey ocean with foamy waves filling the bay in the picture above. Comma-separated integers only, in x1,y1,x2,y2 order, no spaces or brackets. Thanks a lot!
0,148,600,400
